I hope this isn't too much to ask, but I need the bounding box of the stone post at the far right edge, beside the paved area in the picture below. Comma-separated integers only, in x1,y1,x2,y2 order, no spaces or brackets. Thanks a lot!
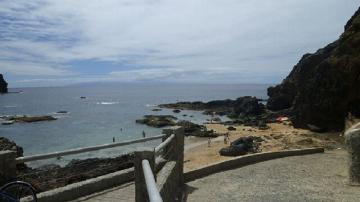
345,125,360,185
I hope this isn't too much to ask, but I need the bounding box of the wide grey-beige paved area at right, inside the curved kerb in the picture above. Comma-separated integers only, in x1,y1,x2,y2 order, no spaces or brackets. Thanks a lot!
187,150,360,202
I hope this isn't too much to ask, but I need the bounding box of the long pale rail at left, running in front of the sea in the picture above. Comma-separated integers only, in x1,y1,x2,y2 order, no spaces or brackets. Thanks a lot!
16,135,165,163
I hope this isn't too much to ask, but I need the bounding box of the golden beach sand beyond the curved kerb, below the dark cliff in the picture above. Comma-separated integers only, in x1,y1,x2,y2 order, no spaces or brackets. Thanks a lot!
184,122,343,172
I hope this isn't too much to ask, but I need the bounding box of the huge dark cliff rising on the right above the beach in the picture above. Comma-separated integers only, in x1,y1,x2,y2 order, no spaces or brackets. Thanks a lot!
267,9,360,130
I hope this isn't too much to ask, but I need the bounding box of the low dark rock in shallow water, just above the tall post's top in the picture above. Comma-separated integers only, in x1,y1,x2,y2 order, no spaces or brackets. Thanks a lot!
136,115,177,128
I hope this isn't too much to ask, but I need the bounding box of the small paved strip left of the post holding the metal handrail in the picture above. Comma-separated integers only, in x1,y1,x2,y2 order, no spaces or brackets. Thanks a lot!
73,182,135,202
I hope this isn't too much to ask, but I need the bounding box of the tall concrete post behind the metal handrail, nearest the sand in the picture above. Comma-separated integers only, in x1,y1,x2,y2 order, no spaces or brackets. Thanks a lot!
174,127,184,187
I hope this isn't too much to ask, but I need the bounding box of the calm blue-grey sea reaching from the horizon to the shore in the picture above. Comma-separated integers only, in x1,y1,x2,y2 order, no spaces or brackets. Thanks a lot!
0,83,269,164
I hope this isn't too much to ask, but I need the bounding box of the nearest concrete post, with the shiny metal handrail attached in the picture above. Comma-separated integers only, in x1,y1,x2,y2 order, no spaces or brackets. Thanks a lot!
134,149,156,202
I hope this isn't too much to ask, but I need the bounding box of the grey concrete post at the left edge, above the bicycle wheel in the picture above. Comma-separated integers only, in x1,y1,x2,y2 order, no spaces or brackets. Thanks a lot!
0,150,16,185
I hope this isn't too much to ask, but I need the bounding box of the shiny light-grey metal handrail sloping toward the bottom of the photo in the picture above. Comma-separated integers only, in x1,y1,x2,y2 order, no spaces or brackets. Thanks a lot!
141,159,163,202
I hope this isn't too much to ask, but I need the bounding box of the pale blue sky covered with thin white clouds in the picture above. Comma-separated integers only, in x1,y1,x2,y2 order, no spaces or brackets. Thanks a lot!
0,0,360,87
